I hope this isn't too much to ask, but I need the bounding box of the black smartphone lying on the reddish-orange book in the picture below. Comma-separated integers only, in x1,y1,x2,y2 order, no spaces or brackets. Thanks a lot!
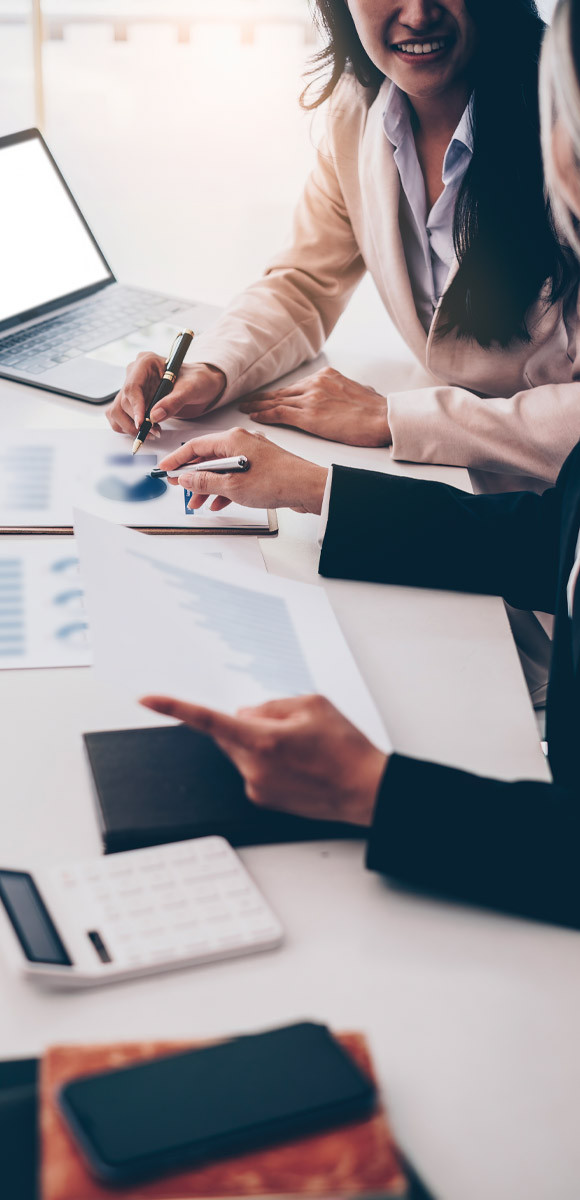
58,1021,376,1184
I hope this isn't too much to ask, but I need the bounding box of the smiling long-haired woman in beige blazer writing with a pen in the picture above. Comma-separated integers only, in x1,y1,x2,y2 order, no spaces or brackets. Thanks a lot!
109,0,580,491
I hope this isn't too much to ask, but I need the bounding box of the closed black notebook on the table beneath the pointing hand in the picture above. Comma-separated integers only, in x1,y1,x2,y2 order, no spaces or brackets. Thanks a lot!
84,725,364,854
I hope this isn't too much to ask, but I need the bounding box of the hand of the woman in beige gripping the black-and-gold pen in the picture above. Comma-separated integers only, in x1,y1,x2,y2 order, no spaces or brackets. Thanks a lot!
107,353,226,437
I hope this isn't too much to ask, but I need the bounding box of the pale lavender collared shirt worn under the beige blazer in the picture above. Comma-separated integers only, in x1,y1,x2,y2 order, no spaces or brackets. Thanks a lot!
383,83,473,332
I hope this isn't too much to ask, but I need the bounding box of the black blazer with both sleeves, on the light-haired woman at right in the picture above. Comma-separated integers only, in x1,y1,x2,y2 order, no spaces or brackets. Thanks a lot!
319,443,580,929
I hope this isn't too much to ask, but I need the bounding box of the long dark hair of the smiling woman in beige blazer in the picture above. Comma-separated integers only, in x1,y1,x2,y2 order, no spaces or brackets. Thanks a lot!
306,0,570,347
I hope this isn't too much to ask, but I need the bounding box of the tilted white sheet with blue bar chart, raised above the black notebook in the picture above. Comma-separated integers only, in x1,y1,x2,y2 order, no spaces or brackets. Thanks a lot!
74,512,389,750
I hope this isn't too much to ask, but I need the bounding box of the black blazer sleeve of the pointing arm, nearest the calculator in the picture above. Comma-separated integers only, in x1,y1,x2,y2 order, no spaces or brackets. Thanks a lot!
366,755,580,929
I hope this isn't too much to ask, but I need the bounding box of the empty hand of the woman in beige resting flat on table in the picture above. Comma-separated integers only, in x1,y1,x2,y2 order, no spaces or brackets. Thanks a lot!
240,367,391,446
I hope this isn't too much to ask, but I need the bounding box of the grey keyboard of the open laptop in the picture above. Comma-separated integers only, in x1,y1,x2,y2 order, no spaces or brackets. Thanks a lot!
0,286,185,376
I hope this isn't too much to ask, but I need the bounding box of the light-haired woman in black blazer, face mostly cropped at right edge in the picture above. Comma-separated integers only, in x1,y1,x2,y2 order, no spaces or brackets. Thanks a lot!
144,0,580,928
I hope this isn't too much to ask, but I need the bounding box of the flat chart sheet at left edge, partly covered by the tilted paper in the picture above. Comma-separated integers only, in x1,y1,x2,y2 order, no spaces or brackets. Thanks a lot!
0,536,265,671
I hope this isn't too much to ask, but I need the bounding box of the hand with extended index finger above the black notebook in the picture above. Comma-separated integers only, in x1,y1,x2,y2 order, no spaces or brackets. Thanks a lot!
140,696,387,826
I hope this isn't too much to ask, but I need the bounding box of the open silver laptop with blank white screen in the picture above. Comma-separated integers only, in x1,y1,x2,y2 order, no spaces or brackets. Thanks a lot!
0,130,217,404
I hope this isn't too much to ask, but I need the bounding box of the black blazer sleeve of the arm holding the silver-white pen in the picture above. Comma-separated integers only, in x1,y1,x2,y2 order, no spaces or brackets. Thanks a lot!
319,467,566,612
